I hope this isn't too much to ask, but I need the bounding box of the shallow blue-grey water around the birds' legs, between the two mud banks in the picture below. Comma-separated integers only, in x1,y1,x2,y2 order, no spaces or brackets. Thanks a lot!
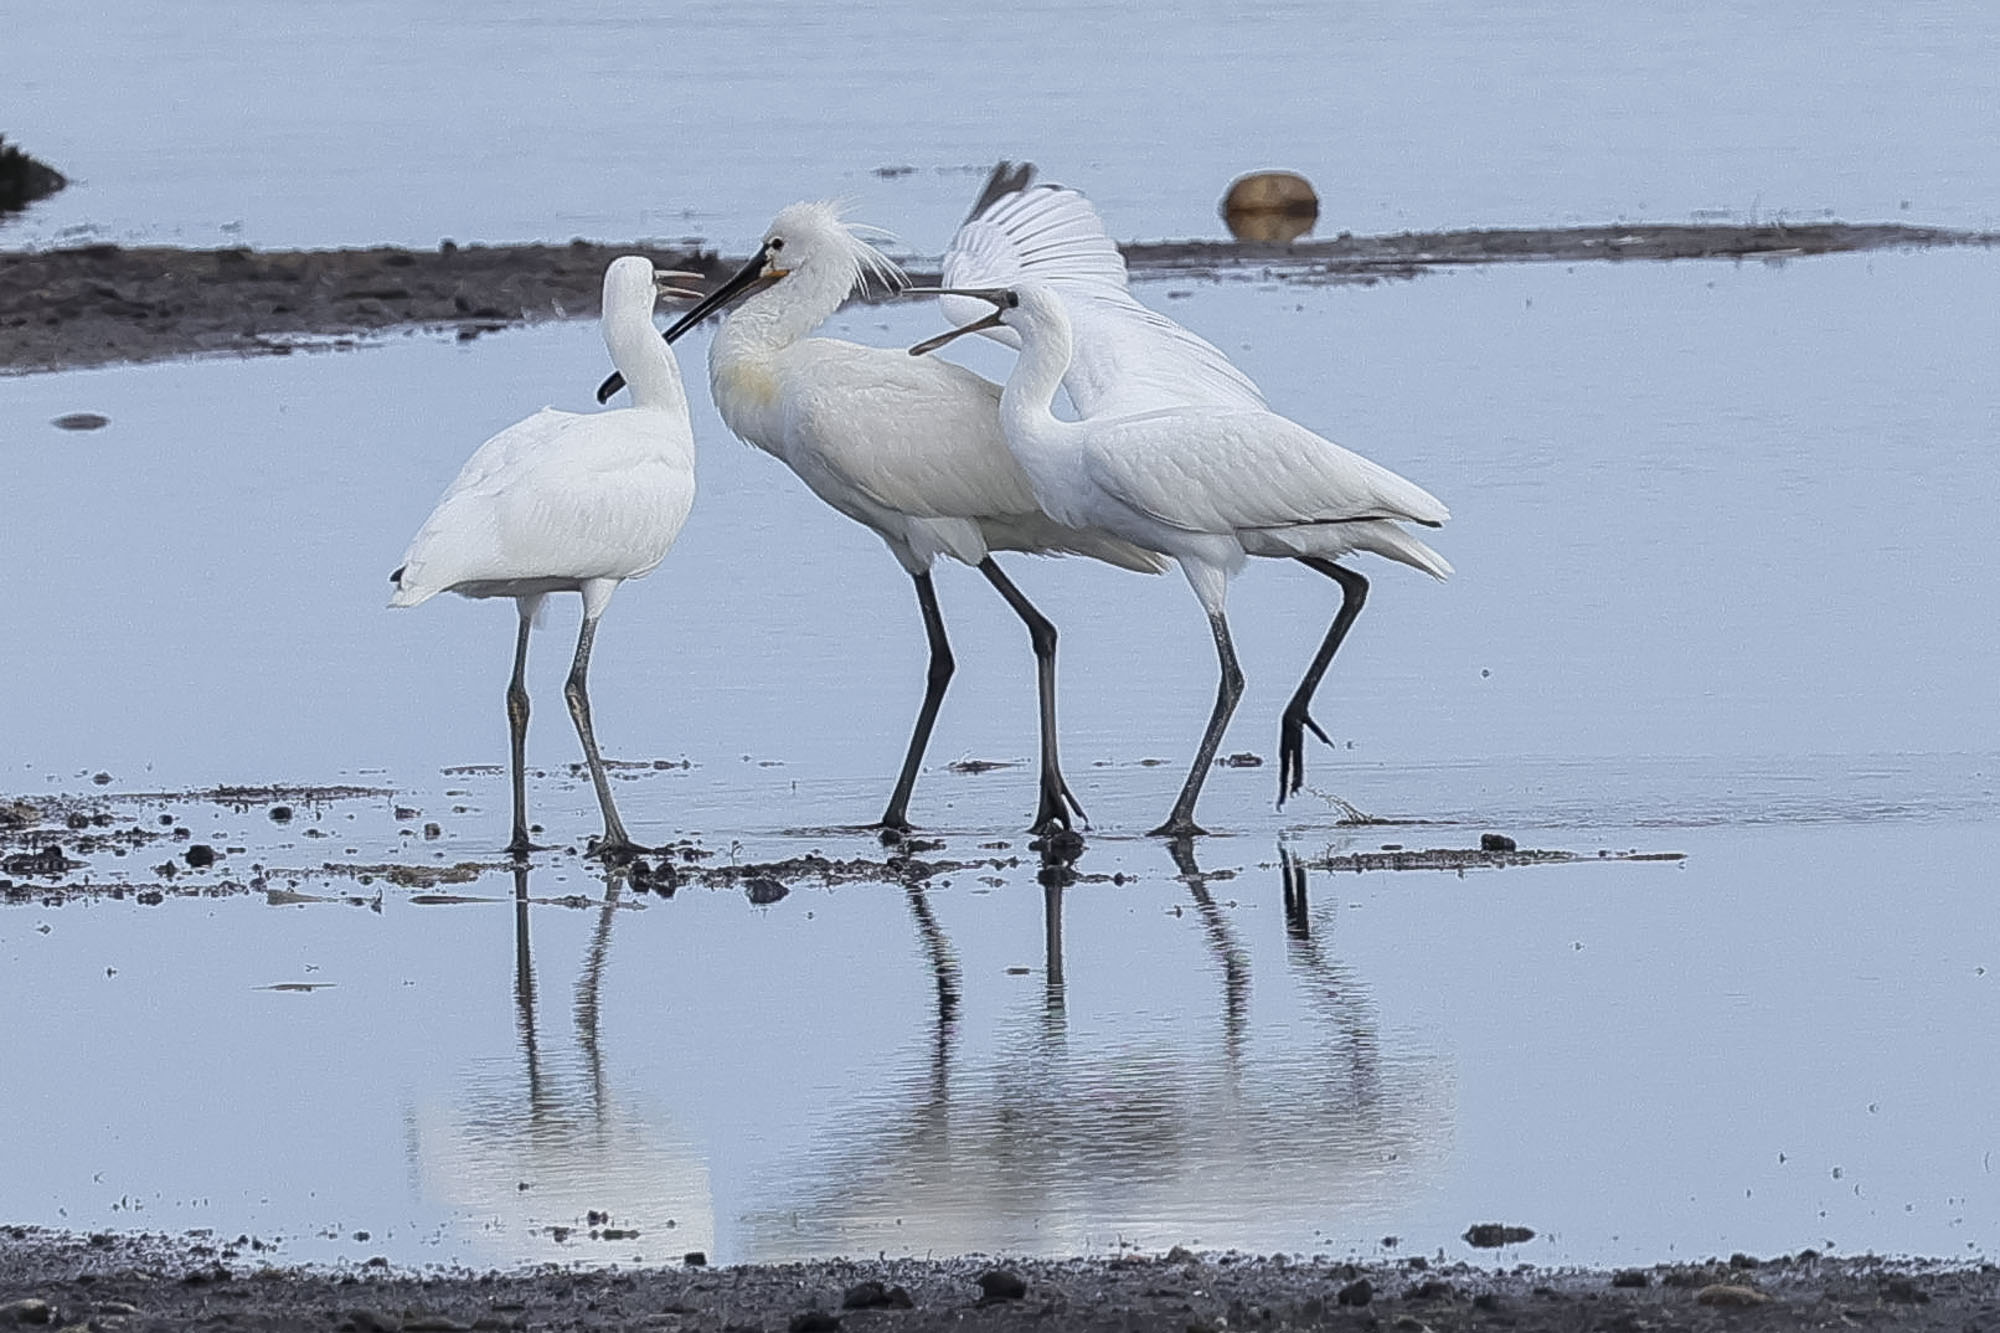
0,252,2000,1265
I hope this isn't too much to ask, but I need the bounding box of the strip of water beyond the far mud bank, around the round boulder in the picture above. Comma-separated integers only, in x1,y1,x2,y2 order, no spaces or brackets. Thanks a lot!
0,0,2000,254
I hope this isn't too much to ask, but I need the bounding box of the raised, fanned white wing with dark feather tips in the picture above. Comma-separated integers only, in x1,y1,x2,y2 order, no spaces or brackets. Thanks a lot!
938,184,1264,416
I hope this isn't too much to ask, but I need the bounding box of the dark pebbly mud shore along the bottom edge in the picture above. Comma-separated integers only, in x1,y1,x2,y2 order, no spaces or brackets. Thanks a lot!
0,1227,2000,1333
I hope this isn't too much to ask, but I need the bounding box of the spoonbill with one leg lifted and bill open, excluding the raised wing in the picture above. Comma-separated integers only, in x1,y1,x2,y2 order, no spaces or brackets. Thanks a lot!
910,282,1452,839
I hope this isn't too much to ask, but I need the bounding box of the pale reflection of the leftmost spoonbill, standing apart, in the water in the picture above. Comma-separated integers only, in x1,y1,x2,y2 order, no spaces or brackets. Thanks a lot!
410,865,714,1265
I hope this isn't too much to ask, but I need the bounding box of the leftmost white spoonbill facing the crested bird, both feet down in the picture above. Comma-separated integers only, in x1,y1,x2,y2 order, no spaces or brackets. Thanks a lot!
388,254,700,861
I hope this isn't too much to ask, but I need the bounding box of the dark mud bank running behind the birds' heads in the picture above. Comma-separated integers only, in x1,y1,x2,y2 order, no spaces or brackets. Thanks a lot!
0,222,2000,374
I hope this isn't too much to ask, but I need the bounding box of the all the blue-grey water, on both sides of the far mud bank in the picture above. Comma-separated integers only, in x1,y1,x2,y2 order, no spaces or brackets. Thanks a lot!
0,6,2000,1265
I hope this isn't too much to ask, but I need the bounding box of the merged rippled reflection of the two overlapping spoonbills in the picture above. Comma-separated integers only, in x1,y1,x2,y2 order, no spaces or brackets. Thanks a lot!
742,847,1454,1261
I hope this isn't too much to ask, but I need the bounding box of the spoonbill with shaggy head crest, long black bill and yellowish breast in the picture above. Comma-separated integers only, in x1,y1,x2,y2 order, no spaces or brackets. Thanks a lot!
598,202,1166,833
